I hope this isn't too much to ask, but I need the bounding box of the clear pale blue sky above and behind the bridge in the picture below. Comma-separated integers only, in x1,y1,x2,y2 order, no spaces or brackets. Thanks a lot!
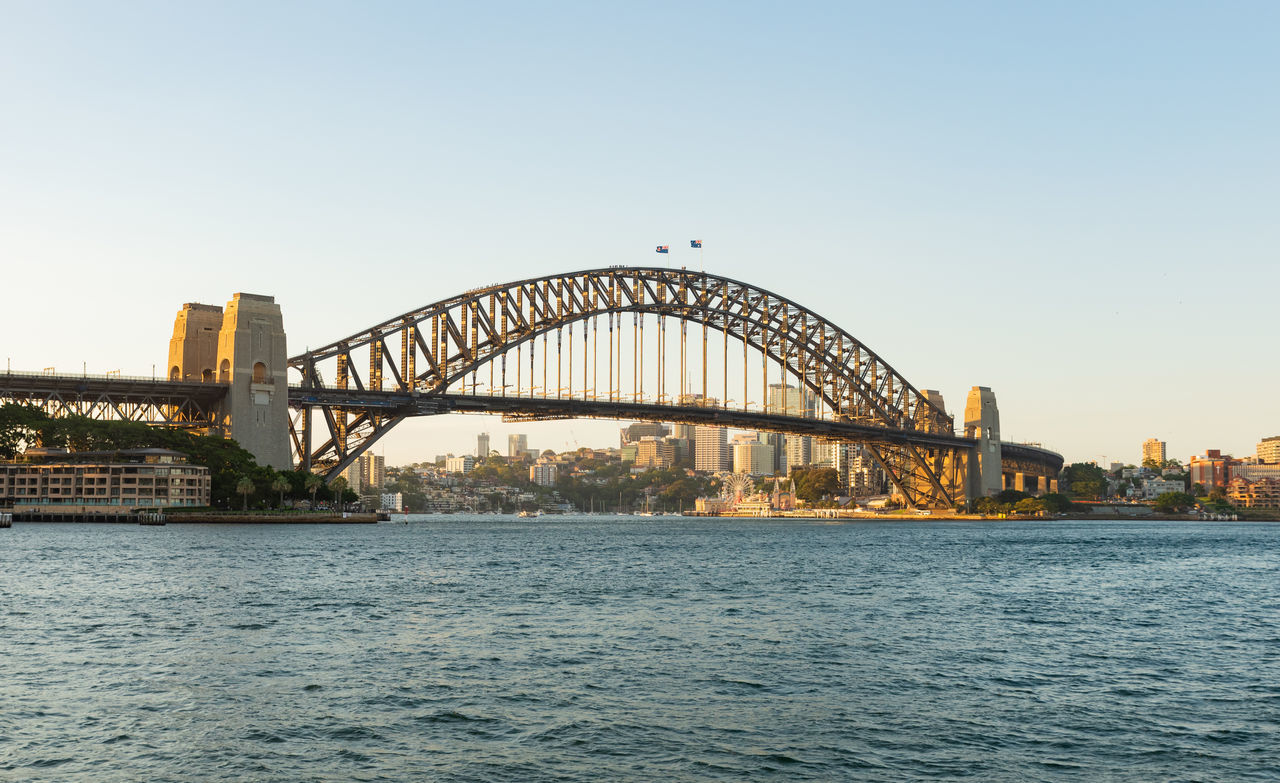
0,0,1280,463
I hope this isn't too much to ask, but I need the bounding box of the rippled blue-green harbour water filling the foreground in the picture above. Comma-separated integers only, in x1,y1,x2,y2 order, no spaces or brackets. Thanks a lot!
0,517,1280,782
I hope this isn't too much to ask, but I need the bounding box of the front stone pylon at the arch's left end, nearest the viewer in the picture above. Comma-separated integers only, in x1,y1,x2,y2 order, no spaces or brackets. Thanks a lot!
218,293,292,471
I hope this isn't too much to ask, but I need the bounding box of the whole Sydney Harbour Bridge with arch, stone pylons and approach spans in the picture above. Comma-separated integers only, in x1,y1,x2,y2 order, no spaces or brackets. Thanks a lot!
0,266,1062,508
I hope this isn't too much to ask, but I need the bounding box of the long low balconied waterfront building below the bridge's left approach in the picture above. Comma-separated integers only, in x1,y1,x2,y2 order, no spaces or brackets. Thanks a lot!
0,449,210,513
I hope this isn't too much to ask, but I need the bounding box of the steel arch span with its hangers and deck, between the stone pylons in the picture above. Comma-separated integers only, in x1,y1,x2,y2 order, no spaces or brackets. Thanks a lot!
289,267,973,507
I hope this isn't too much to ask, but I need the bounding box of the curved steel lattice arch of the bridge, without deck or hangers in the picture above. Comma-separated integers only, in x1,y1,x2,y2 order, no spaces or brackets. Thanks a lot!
289,266,963,505
